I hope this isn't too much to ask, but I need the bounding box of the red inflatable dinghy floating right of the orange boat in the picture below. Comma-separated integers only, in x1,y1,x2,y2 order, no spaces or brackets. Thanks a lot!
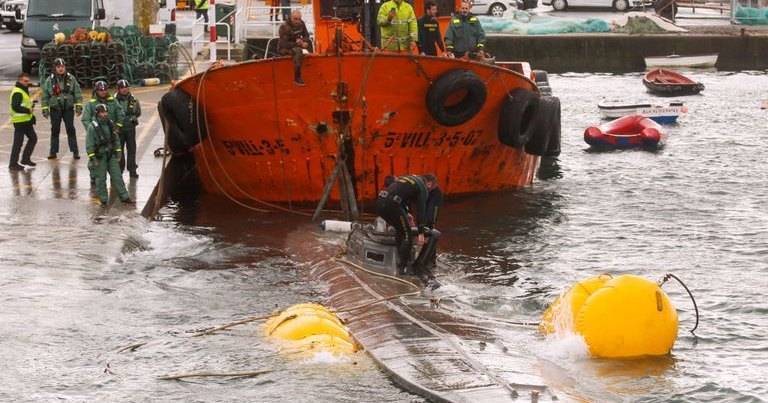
584,115,666,148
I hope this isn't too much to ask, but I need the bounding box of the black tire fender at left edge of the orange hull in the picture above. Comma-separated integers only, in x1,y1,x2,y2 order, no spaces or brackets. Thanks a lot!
157,88,207,153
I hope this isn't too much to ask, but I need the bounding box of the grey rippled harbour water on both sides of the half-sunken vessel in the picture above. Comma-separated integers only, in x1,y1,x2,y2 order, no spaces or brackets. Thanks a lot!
0,72,768,402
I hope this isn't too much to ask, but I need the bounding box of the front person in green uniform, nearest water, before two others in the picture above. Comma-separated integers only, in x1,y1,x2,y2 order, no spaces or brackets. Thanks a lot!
85,104,133,206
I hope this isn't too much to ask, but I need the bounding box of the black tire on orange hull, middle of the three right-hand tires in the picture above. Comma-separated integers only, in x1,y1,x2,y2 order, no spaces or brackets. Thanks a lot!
497,88,539,147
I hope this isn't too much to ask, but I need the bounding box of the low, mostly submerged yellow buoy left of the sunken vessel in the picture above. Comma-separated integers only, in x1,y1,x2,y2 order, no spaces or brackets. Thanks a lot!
264,304,357,353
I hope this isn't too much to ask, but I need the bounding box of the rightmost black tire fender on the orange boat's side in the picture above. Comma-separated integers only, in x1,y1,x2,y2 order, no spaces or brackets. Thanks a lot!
525,97,560,156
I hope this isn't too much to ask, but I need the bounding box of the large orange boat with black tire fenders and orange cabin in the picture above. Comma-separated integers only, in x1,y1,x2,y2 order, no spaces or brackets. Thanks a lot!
160,0,560,210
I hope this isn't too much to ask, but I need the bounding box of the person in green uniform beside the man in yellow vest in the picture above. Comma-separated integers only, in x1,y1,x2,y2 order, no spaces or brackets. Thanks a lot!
42,58,83,160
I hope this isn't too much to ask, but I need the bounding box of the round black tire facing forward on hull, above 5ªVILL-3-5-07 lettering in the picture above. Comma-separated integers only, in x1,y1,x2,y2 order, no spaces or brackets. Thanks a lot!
427,70,488,126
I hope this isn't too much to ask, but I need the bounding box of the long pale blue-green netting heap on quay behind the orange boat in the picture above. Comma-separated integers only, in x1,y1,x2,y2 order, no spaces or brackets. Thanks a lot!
479,12,611,35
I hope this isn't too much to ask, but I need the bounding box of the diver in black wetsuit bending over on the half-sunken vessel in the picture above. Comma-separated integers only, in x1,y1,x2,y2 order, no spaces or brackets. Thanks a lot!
376,174,443,288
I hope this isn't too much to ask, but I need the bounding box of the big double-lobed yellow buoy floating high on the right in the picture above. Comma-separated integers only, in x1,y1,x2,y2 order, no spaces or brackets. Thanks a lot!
539,275,677,358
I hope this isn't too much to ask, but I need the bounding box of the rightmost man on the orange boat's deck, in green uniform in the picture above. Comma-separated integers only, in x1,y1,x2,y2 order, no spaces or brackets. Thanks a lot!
445,1,485,59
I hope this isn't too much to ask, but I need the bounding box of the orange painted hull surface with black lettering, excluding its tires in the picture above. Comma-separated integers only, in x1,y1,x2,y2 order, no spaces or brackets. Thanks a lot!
178,53,539,203
